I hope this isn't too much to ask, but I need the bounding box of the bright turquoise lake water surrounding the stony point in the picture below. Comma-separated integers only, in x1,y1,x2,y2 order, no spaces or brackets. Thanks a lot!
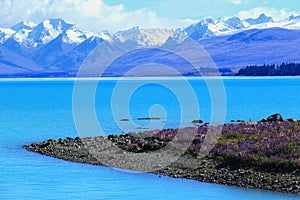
0,77,300,200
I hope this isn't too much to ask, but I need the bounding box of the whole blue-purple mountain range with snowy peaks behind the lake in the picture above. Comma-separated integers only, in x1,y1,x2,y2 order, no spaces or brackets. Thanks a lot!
0,14,300,77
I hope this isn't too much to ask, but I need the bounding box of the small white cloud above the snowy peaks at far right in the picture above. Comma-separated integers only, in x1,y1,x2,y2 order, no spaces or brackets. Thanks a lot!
237,7,298,21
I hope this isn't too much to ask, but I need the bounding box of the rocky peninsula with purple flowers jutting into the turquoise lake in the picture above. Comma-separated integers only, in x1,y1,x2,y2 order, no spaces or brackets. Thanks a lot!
24,114,300,195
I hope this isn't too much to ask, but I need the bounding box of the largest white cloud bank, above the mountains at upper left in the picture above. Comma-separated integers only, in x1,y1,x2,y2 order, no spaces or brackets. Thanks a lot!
0,0,190,32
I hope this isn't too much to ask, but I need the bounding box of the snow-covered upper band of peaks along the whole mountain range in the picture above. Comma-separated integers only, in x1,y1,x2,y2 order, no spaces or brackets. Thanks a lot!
0,13,300,51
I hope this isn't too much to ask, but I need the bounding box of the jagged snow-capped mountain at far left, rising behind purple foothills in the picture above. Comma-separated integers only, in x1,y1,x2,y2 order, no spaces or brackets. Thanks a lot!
0,19,115,71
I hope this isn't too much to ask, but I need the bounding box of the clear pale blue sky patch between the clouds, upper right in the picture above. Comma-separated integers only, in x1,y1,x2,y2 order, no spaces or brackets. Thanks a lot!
105,0,300,19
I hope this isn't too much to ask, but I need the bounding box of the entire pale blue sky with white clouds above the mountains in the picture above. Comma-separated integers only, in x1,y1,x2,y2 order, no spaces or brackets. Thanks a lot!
0,0,300,32
